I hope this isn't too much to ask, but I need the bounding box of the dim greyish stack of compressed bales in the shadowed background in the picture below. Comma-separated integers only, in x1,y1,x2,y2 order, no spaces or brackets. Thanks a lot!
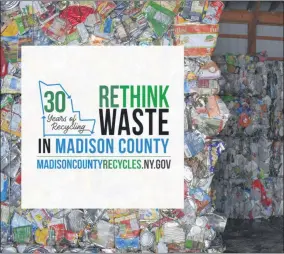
213,52,283,219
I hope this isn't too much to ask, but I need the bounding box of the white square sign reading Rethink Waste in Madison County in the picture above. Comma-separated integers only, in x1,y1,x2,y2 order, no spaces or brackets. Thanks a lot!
22,46,184,209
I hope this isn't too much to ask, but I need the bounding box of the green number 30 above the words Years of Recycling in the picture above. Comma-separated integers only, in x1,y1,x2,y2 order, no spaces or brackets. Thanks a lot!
44,91,66,113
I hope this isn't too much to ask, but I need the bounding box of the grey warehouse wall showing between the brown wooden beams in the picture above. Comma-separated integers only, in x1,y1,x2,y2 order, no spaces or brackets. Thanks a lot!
214,23,284,57
